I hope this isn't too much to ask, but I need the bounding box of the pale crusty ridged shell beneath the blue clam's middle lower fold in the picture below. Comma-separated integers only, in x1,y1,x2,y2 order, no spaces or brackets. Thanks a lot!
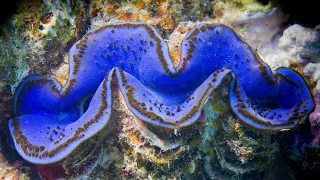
116,89,200,179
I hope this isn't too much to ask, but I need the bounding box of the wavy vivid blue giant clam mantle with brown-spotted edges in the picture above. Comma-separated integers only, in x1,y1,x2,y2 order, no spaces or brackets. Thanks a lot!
9,23,314,164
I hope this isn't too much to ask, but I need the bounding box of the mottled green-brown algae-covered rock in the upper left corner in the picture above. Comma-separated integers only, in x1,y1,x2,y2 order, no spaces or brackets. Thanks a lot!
0,0,84,89
